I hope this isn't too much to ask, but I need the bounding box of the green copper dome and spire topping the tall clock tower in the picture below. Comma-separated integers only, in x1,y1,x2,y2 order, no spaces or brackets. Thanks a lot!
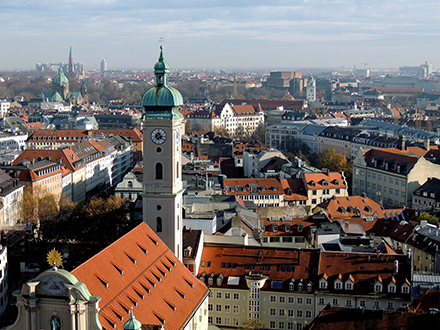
142,46,183,107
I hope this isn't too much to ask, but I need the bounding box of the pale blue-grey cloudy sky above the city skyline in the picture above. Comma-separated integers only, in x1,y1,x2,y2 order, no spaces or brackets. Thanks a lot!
0,0,440,71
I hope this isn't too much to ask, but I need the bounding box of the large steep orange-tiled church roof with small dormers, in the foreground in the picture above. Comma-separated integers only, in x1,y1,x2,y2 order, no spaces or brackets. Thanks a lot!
72,223,208,329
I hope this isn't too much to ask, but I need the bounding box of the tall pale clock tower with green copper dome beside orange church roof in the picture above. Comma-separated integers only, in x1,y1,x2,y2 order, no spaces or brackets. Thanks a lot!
142,46,183,260
